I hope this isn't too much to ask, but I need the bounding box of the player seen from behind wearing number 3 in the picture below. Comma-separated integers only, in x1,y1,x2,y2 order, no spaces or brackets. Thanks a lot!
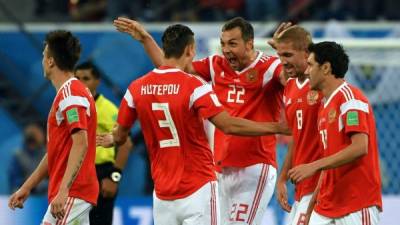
106,24,288,225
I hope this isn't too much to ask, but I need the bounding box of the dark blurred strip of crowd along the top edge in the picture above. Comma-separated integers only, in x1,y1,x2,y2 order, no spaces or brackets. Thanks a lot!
3,0,400,22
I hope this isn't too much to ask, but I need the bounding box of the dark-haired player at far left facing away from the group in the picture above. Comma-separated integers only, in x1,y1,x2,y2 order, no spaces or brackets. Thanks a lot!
8,30,99,225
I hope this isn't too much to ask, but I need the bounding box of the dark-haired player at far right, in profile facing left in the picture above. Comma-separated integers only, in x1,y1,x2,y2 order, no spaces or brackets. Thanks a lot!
288,42,382,225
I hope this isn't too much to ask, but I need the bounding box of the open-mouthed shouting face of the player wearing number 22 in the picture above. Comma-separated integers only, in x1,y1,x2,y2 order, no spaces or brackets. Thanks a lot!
220,27,254,71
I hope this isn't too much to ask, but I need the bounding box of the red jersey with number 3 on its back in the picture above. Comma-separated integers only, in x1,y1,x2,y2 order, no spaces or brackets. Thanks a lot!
118,66,223,200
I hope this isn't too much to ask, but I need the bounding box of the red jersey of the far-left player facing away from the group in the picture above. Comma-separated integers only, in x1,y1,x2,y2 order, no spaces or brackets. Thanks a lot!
47,78,99,205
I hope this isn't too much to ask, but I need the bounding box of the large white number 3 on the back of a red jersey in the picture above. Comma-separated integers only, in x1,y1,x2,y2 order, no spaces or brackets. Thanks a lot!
151,103,180,148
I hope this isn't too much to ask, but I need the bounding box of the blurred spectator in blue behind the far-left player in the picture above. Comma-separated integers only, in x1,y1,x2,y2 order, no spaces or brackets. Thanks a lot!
8,123,48,195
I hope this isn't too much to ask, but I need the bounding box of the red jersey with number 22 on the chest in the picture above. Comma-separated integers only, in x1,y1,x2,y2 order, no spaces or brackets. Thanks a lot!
193,52,283,167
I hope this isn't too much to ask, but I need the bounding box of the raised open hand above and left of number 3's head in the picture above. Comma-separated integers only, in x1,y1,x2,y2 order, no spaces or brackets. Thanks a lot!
114,17,150,42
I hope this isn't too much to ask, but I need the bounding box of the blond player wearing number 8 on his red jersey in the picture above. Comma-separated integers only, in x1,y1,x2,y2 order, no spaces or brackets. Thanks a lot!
271,23,322,225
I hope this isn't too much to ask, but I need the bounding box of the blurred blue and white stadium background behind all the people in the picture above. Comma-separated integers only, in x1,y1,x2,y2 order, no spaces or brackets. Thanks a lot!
0,0,400,225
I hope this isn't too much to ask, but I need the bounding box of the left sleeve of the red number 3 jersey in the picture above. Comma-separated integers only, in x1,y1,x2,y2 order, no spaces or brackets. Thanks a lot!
117,89,137,127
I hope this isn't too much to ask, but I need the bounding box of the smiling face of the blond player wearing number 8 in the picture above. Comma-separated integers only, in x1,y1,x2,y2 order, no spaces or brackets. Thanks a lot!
276,41,308,77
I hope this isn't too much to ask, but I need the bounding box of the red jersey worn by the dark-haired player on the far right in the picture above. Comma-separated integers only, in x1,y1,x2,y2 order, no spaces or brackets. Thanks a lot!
315,82,382,218
